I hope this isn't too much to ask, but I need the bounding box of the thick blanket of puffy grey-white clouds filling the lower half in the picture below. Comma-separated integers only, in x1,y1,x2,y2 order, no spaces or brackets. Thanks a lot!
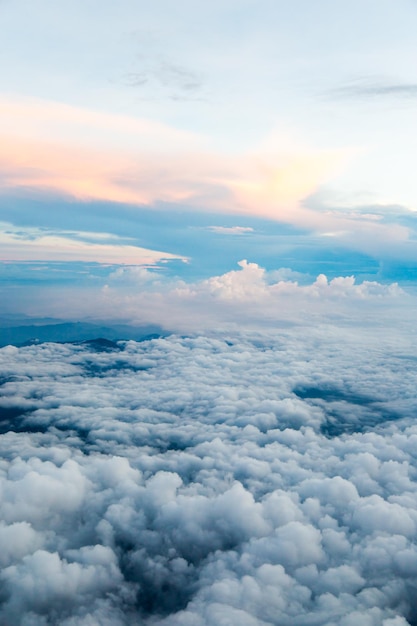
0,316,417,626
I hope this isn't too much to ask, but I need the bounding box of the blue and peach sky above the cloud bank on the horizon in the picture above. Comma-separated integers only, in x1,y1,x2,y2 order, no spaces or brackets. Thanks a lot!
0,0,417,322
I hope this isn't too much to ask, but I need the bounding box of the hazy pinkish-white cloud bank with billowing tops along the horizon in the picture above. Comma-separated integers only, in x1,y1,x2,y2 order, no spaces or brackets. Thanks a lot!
0,259,406,332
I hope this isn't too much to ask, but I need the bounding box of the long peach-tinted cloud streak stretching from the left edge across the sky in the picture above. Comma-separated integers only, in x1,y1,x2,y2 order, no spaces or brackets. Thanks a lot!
0,91,346,222
